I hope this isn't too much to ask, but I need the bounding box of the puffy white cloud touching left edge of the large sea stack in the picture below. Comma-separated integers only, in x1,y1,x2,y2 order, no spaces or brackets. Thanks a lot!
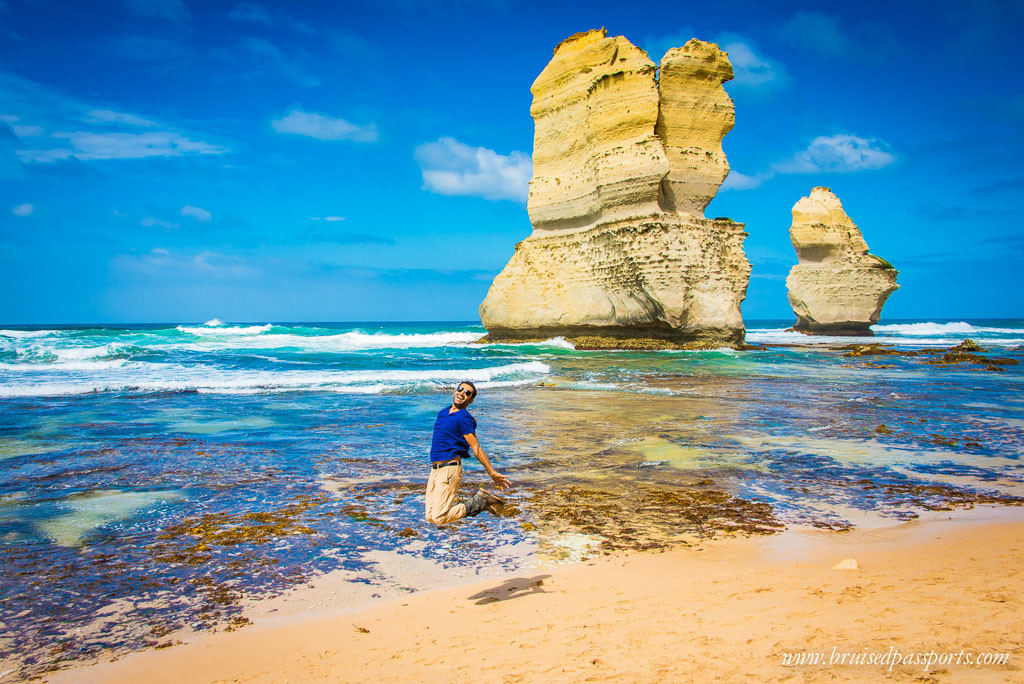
416,137,534,203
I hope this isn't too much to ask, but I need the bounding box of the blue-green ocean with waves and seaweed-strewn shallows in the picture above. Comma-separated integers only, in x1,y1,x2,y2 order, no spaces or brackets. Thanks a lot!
0,319,1024,675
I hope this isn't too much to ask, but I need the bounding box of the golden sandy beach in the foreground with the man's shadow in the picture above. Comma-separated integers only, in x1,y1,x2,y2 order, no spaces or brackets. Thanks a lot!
48,507,1024,682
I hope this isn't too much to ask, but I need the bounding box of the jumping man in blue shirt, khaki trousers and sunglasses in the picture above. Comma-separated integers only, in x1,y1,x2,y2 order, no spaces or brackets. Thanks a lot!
427,381,511,525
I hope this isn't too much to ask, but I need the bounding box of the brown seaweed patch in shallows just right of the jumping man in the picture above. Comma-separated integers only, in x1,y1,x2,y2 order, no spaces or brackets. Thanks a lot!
527,486,783,553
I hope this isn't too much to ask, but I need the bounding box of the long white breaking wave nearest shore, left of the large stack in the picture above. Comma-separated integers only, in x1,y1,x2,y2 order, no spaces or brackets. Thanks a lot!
0,361,551,396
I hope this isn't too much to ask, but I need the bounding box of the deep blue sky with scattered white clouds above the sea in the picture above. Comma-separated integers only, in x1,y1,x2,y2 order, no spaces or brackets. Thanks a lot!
0,0,1024,324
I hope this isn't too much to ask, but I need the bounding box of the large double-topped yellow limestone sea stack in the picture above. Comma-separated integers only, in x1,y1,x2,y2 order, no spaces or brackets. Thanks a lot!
480,29,751,348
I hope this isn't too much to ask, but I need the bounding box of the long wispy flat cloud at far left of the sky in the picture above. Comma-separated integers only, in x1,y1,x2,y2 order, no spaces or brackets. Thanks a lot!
17,131,228,163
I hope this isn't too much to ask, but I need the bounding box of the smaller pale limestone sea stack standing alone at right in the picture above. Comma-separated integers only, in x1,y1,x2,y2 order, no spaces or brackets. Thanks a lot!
785,187,899,335
